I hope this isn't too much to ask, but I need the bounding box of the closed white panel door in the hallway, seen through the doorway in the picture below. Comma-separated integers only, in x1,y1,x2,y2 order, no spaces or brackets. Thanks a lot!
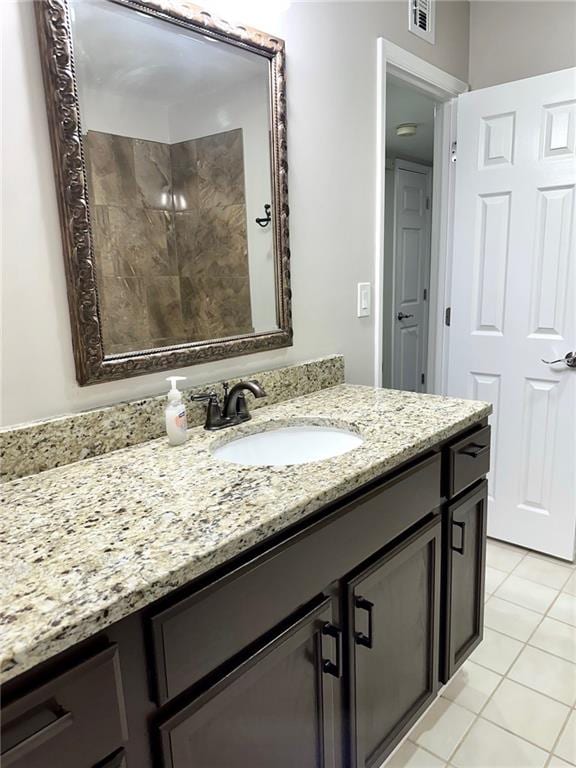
392,160,430,392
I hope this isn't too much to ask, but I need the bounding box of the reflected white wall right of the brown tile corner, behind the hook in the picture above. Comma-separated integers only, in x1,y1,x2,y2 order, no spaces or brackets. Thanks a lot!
169,74,278,333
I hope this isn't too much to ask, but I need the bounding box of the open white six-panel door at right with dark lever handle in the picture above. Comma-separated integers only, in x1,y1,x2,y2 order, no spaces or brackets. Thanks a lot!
448,69,576,559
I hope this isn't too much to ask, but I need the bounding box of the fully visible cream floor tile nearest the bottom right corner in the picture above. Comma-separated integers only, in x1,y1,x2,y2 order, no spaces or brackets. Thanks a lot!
482,680,570,750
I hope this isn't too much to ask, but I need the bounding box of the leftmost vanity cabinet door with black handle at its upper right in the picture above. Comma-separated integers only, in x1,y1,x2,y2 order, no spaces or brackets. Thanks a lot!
160,599,342,768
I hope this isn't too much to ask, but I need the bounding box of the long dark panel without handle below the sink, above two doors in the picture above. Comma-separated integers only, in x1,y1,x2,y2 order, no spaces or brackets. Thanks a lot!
151,455,440,704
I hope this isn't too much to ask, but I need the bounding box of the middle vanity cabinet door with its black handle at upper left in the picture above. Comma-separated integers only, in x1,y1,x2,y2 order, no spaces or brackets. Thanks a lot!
348,517,441,768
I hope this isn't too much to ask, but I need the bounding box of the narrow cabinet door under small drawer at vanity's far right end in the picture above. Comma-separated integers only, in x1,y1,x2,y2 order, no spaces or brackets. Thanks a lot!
442,480,488,682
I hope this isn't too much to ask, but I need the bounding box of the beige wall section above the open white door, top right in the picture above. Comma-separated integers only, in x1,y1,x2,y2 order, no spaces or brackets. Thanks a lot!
469,0,576,88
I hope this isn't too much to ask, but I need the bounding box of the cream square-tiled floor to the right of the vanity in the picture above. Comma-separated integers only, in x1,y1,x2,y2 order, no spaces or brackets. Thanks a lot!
383,540,576,768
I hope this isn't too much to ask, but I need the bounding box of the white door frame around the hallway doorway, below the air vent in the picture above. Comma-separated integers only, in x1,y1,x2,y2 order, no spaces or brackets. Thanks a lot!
374,37,469,394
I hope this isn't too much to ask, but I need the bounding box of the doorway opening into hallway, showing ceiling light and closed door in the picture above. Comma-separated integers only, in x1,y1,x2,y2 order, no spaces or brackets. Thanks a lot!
382,74,436,392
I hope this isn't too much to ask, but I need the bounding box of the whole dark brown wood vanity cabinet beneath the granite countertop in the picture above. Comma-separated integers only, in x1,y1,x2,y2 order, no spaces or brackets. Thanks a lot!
2,424,490,768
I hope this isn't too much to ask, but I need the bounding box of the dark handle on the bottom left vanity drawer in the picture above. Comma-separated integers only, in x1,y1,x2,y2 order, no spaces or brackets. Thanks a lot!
2,700,74,768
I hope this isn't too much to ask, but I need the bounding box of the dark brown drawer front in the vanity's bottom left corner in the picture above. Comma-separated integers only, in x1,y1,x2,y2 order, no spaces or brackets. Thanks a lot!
2,646,127,768
